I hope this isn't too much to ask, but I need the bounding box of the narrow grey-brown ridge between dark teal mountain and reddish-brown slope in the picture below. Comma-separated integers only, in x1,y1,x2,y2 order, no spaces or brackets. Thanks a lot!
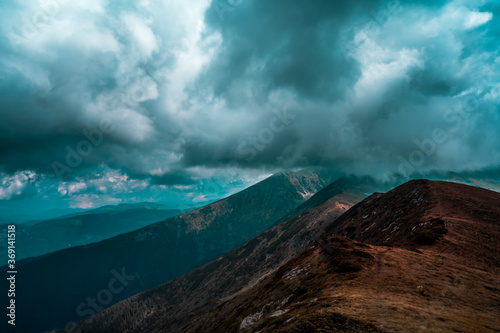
66,176,392,332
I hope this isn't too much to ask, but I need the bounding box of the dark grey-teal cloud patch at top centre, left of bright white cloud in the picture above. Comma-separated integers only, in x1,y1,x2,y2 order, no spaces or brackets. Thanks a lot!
200,0,379,100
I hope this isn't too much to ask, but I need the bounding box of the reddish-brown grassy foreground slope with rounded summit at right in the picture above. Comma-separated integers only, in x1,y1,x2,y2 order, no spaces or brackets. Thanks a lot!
184,181,500,332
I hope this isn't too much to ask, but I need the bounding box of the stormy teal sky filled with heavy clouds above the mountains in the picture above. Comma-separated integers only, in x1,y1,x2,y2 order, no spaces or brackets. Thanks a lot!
0,0,500,210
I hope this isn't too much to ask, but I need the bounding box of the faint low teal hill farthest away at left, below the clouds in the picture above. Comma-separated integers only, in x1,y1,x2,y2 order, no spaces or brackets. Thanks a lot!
0,203,183,260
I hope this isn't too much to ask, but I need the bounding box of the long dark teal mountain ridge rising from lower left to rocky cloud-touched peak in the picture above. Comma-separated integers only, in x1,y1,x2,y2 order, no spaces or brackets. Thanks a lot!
4,172,327,332
